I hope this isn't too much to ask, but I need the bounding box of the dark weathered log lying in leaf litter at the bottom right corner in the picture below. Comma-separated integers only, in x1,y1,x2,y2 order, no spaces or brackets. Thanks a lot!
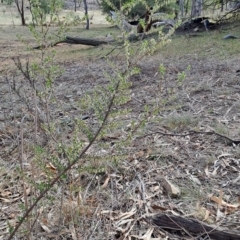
149,214,240,240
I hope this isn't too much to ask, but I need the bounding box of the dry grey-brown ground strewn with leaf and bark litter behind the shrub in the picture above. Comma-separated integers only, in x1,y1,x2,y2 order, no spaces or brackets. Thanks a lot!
0,3,240,240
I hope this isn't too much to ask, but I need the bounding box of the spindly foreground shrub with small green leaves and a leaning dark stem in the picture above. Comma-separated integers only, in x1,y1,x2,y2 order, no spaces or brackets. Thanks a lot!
6,0,178,234
